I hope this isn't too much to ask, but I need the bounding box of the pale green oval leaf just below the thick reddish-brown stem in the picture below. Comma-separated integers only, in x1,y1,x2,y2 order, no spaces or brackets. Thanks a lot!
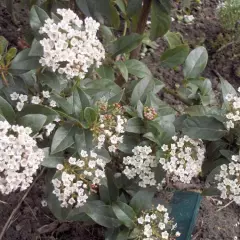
125,59,152,78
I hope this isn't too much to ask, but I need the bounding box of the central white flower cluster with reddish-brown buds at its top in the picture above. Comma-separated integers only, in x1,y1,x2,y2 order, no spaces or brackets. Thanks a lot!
91,101,127,152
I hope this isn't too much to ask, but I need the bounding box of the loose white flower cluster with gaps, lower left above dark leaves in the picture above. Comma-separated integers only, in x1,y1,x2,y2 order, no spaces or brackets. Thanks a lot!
52,150,106,208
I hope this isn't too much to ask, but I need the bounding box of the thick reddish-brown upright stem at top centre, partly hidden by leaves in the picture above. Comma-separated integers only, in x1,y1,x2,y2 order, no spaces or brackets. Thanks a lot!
130,0,152,59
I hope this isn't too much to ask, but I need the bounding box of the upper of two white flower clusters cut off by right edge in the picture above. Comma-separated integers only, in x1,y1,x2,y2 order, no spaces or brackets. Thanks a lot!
226,88,240,129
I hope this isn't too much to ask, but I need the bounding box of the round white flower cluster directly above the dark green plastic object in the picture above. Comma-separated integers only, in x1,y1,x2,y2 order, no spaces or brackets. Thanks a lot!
159,136,205,183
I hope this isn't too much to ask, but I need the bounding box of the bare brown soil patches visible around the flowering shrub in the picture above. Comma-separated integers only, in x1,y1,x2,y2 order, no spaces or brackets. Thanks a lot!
0,0,240,240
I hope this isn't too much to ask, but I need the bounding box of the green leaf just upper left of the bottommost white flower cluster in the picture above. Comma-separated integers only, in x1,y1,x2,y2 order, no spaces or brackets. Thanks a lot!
112,201,136,228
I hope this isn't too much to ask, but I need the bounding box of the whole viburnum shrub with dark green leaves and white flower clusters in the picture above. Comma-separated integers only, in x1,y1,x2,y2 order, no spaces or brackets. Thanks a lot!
0,0,240,240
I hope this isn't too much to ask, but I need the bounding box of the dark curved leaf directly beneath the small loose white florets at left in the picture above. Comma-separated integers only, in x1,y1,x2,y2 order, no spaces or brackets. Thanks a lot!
20,104,58,124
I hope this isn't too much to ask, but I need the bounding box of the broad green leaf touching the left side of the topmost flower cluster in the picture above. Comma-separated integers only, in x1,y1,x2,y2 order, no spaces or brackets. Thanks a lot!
9,49,41,74
